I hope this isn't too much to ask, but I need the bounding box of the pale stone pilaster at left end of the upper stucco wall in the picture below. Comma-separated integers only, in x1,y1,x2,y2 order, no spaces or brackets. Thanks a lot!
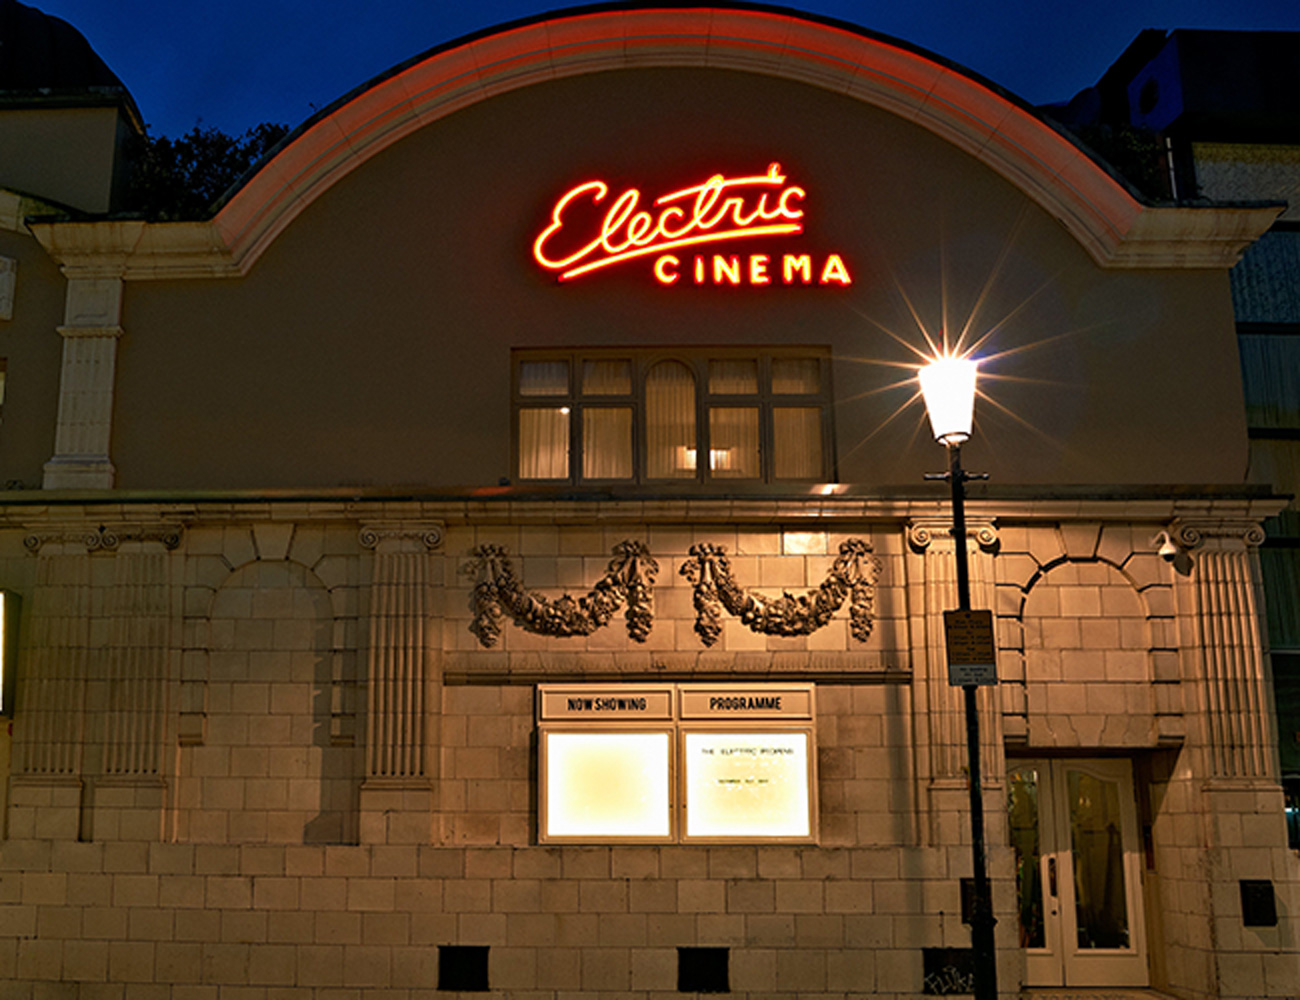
44,267,122,489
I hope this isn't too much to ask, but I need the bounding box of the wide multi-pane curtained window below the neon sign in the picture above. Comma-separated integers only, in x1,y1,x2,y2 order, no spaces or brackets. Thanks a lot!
514,347,831,484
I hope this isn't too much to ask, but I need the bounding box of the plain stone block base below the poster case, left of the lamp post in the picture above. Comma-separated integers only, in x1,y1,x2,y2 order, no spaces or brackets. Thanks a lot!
0,841,1015,1000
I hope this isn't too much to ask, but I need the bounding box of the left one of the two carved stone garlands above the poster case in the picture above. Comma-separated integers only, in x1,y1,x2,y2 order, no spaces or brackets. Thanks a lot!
465,541,659,648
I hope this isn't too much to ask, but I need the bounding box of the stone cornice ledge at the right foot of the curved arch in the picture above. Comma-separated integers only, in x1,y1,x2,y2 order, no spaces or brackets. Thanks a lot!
1101,204,1286,269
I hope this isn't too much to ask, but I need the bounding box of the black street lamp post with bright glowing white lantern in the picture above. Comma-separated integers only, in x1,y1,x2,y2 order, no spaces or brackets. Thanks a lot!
918,358,997,1000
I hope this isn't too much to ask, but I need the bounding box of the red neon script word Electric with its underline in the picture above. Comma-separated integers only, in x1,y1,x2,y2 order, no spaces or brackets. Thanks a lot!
533,163,806,283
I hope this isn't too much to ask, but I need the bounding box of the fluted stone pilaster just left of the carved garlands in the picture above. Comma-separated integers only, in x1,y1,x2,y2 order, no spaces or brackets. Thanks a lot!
360,523,443,844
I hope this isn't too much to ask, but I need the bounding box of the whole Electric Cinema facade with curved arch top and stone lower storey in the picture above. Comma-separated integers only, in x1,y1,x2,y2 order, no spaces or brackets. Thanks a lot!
0,8,1300,1000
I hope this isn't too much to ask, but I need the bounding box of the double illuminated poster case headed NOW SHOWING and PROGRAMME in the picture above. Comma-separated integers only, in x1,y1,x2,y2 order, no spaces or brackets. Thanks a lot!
537,684,818,843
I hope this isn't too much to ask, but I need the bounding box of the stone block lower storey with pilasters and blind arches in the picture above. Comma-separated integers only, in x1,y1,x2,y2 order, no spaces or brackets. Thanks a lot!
0,502,1300,1000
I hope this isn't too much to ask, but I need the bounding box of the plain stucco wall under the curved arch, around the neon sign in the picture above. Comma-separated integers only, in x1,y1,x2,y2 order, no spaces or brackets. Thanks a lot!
112,69,1245,489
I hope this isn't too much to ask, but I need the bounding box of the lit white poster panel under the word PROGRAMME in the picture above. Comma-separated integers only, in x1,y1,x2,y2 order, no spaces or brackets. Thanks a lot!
684,732,813,839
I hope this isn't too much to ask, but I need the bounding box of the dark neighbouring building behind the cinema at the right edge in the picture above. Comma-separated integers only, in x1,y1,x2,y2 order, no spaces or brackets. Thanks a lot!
1050,30,1300,848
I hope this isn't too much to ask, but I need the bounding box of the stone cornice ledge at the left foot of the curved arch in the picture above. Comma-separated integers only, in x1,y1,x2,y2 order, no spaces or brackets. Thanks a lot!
30,220,243,281
